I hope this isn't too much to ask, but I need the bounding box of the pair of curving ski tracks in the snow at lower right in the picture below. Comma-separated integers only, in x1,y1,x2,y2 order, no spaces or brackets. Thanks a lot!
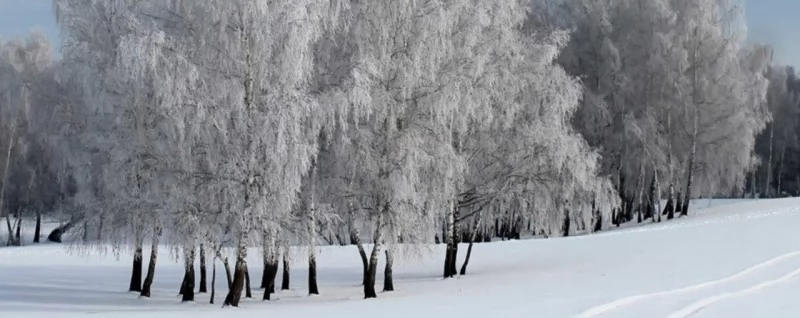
576,251,800,318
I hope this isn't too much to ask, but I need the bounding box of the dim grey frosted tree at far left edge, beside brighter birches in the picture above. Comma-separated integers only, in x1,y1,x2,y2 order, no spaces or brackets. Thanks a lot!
0,31,58,245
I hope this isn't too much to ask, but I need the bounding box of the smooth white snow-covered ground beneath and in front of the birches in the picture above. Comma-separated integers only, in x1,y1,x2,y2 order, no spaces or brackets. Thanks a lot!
0,199,800,318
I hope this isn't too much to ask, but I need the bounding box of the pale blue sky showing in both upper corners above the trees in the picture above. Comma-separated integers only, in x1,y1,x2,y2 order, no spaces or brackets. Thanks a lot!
0,0,800,66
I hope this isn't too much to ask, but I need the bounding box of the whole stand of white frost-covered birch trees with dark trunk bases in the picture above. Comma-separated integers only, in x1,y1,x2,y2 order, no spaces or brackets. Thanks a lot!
0,0,797,306
